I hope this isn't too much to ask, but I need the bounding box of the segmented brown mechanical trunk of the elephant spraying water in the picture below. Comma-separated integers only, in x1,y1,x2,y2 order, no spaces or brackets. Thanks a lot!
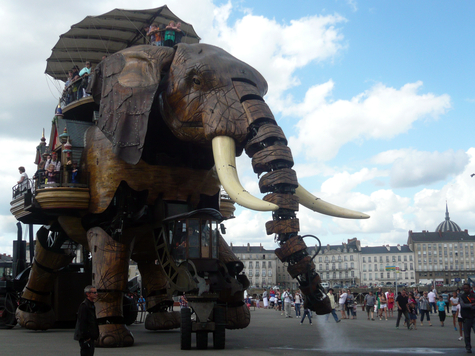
234,81,331,314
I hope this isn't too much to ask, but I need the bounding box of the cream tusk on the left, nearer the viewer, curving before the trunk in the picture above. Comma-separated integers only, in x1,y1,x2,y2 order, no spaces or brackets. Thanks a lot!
212,136,279,211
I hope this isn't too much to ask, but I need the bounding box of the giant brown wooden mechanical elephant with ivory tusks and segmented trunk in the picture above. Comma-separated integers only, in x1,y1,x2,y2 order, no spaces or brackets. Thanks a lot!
17,44,368,346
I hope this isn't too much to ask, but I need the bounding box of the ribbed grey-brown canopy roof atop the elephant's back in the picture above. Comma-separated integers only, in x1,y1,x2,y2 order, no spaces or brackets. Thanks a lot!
45,5,200,81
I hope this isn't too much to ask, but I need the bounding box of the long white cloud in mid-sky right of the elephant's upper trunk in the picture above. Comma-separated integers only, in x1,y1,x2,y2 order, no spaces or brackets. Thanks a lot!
284,81,451,161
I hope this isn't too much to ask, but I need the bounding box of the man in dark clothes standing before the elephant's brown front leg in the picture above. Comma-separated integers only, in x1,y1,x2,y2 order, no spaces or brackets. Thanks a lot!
74,286,99,356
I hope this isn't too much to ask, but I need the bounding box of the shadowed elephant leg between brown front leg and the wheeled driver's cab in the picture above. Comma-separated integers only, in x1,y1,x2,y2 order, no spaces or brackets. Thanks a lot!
138,261,180,330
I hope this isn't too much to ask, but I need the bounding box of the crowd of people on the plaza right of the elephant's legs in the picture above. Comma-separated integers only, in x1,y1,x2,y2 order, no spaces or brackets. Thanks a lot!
246,284,475,353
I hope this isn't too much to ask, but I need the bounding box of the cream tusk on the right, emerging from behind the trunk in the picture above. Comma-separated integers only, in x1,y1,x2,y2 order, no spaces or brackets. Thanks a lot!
295,185,369,219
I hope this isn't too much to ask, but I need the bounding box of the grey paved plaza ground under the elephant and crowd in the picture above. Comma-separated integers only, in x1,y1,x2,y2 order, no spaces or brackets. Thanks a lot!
0,309,468,356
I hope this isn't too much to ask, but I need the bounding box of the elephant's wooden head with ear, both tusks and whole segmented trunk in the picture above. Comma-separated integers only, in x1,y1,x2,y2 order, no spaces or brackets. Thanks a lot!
89,44,369,313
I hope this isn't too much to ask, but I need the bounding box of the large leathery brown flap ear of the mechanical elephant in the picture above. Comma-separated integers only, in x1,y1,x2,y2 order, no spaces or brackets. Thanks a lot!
88,46,175,164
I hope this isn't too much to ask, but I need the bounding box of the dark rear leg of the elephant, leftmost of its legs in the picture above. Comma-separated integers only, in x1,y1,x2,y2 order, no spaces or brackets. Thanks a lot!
16,227,75,330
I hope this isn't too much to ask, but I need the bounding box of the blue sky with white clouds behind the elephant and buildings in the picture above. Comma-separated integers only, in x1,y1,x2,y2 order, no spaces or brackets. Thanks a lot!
0,0,475,253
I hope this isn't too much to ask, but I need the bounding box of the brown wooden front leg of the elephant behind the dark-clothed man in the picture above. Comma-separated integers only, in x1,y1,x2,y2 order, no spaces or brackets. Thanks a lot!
87,227,134,347
